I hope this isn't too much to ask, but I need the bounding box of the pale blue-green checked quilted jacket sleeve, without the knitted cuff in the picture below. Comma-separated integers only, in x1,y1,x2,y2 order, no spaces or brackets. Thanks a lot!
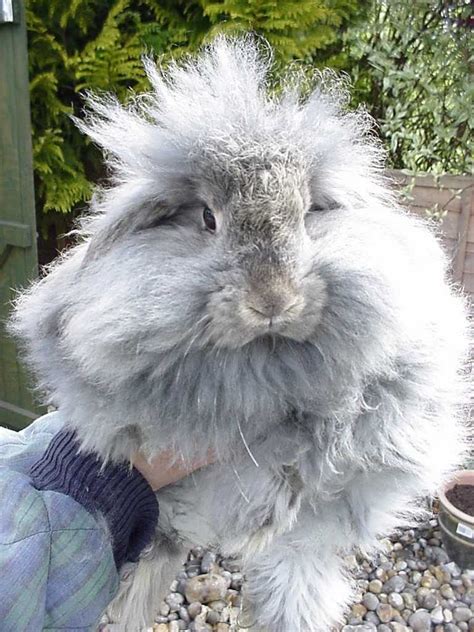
0,413,118,632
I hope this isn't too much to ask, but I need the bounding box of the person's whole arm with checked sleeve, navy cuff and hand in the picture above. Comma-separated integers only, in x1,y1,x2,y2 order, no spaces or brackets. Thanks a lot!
0,420,211,632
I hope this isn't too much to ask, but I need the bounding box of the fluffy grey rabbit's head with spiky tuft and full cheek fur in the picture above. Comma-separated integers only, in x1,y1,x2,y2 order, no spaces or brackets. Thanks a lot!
14,39,466,460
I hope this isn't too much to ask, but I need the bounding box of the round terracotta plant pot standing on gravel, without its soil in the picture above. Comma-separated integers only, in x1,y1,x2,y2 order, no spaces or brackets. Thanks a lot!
438,470,474,569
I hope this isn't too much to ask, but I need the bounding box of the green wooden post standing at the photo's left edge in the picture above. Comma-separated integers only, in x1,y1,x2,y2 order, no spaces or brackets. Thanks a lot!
0,0,39,428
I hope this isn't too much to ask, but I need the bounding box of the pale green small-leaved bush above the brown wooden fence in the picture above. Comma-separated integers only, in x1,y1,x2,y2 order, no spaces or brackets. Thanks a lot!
345,0,474,174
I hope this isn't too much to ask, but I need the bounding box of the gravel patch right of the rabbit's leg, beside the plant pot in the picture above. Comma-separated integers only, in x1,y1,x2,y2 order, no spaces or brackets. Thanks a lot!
342,518,474,632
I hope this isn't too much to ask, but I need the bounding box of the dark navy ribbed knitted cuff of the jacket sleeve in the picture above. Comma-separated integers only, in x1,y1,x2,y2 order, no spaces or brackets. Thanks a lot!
30,430,158,568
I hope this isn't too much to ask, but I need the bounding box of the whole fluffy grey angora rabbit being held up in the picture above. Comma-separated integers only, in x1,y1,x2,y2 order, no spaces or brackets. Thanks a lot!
13,38,467,632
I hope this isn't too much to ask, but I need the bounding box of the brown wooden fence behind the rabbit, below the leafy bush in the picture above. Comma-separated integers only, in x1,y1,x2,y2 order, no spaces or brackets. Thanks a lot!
390,171,474,300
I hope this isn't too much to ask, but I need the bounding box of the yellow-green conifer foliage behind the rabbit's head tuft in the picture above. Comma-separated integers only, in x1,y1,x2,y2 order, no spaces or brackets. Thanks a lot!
27,0,364,226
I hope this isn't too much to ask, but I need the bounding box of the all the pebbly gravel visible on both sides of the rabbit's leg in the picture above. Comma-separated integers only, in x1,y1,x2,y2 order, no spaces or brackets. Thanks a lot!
101,518,474,632
